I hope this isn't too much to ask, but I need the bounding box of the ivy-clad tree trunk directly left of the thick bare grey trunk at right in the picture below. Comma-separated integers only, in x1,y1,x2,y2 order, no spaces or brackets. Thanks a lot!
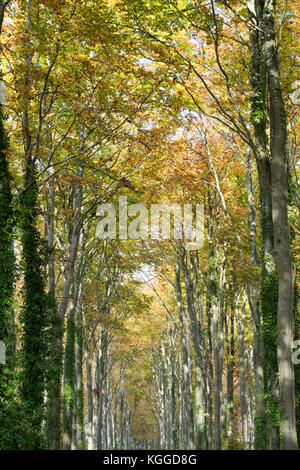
247,0,279,449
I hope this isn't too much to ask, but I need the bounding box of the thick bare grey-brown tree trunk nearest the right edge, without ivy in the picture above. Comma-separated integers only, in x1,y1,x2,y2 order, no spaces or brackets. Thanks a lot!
259,0,298,450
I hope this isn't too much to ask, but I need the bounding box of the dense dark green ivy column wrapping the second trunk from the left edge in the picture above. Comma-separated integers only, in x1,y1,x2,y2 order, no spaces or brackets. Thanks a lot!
20,161,48,449
